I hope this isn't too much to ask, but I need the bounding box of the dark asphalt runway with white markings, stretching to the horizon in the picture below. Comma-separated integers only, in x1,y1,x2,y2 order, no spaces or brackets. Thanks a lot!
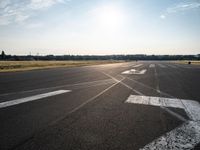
0,61,200,150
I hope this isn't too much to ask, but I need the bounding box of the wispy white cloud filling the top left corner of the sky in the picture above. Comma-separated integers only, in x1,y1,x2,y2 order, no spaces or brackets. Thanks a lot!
0,0,65,25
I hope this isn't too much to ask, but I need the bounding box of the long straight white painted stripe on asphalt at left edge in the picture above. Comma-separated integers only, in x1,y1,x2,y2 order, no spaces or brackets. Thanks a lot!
0,90,70,108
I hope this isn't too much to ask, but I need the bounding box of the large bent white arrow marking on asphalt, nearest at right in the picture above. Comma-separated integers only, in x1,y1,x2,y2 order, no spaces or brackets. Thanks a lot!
126,95,200,150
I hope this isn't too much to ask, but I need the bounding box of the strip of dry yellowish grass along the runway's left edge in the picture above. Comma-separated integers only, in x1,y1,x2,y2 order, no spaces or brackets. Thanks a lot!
0,60,122,72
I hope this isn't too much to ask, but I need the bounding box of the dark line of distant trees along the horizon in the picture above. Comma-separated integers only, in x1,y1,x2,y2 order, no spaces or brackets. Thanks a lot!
0,51,200,61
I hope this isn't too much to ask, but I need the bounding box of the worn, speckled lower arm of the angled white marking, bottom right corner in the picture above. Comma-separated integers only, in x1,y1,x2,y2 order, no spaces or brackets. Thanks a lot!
140,121,200,150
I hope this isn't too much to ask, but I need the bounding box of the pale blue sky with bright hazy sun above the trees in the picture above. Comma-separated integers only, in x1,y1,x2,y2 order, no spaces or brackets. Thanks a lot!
0,0,200,55
